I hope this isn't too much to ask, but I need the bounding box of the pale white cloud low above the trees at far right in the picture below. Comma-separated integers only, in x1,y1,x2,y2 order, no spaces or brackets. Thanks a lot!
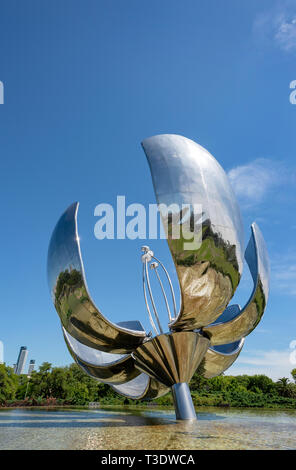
226,349,296,380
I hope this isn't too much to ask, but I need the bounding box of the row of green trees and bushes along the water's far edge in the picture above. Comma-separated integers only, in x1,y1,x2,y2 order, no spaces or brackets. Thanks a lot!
0,362,296,408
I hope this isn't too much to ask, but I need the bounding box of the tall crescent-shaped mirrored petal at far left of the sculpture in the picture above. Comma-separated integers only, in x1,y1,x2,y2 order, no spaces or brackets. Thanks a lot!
47,203,146,354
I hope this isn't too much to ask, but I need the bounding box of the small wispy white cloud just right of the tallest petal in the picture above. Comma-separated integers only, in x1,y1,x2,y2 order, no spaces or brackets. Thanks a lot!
228,158,285,205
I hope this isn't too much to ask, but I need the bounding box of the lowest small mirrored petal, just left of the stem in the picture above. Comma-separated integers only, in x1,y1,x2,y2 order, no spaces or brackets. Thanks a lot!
111,373,170,400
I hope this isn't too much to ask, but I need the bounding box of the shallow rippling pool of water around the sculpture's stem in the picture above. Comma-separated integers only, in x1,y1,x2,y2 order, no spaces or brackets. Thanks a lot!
0,408,296,450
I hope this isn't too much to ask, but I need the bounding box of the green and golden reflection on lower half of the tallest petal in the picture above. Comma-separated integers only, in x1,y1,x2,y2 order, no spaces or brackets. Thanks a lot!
168,219,240,329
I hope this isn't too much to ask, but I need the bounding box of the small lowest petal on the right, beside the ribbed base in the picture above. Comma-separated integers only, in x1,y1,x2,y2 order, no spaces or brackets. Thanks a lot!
204,338,245,379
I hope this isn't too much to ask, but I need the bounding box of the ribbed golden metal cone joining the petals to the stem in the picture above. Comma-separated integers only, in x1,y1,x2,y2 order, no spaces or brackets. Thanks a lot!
132,331,210,387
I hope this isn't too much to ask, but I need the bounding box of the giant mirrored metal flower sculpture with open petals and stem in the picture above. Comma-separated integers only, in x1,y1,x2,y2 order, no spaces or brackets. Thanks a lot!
48,135,269,419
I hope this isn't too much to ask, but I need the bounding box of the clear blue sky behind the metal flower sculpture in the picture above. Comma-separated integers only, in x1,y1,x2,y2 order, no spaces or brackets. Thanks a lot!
0,0,296,378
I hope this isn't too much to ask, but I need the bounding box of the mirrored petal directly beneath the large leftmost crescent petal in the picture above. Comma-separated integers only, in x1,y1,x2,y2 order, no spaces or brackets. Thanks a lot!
63,328,140,384
